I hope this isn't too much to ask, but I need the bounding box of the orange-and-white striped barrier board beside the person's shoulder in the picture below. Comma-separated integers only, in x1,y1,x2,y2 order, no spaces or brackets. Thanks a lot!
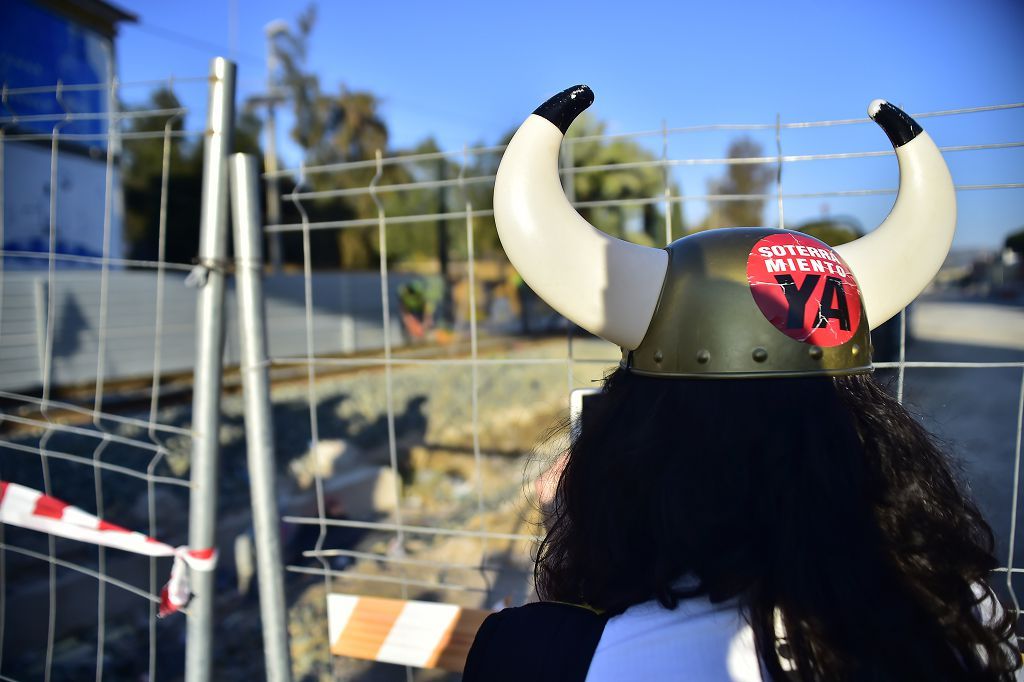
327,594,490,673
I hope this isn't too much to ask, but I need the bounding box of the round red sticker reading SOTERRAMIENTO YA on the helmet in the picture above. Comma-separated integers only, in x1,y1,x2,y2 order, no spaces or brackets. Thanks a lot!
746,232,861,346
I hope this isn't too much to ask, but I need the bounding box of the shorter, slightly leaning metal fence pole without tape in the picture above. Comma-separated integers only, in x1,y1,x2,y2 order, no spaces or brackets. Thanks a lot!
230,154,291,682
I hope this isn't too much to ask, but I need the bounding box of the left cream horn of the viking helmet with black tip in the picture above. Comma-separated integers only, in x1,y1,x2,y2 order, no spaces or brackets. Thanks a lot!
495,85,669,350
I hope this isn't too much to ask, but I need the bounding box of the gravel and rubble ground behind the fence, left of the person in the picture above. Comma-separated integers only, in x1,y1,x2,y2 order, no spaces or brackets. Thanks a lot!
0,338,615,681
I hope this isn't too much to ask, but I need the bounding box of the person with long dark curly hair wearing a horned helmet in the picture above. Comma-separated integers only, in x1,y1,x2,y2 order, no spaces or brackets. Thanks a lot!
463,86,1022,682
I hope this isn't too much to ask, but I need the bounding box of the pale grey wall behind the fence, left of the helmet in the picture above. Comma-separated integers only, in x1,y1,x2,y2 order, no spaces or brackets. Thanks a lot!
0,270,423,391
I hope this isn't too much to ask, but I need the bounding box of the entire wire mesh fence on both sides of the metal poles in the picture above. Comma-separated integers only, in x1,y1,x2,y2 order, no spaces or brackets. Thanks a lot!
0,57,1024,680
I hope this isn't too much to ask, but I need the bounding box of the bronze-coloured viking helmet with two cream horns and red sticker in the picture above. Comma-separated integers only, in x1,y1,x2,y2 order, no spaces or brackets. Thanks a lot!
495,85,956,378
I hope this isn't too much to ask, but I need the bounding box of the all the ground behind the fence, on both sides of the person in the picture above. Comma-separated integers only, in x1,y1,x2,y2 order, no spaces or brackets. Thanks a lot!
0,292,1024,682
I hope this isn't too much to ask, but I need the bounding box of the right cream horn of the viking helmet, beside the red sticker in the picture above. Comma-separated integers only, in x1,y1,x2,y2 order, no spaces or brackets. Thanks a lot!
836,99,956,329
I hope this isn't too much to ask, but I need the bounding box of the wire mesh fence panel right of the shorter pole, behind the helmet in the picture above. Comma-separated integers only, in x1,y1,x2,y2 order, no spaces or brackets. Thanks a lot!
264,103,1024,679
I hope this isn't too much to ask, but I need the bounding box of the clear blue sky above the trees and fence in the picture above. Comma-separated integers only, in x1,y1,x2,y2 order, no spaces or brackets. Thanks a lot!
112,0,1024,247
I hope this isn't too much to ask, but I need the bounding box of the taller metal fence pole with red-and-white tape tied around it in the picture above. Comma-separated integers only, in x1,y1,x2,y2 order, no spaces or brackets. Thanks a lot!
185,57,236,682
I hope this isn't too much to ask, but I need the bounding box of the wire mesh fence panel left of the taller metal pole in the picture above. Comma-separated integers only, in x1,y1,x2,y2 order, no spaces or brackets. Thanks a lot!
0,77,216,680
